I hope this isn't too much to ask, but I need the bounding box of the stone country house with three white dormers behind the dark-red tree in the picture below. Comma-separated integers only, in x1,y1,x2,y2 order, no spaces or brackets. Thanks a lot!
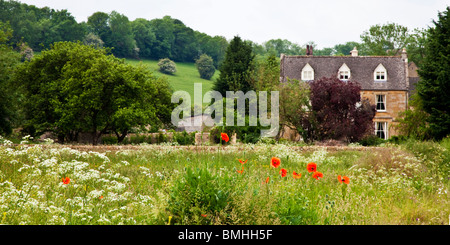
280,47,419,139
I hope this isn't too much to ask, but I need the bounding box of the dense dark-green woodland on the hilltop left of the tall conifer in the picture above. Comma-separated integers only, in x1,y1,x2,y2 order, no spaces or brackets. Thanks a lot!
0,0,228,67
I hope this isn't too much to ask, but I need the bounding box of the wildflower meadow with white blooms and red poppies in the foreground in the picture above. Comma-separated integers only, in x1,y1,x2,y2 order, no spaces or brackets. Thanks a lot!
0,135,450,225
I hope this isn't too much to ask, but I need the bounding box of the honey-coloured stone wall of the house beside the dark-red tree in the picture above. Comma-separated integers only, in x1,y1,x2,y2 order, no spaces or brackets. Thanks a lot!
361,91,408,137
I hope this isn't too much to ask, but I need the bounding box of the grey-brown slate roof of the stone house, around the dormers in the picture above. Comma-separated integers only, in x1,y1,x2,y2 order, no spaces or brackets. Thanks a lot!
280,55,409,91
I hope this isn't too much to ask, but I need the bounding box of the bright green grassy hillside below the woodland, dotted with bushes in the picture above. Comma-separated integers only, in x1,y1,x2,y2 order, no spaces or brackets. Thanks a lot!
126,59,219,106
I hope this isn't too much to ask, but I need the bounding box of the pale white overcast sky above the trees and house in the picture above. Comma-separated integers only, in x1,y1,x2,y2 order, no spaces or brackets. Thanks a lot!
19,0,450,48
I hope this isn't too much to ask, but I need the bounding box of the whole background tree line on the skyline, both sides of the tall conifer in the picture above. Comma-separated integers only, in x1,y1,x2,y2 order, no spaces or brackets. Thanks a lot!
0,0,427,68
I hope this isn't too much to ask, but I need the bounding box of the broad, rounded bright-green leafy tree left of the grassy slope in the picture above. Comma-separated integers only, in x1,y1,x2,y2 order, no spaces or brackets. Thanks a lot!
16,42,172,144
